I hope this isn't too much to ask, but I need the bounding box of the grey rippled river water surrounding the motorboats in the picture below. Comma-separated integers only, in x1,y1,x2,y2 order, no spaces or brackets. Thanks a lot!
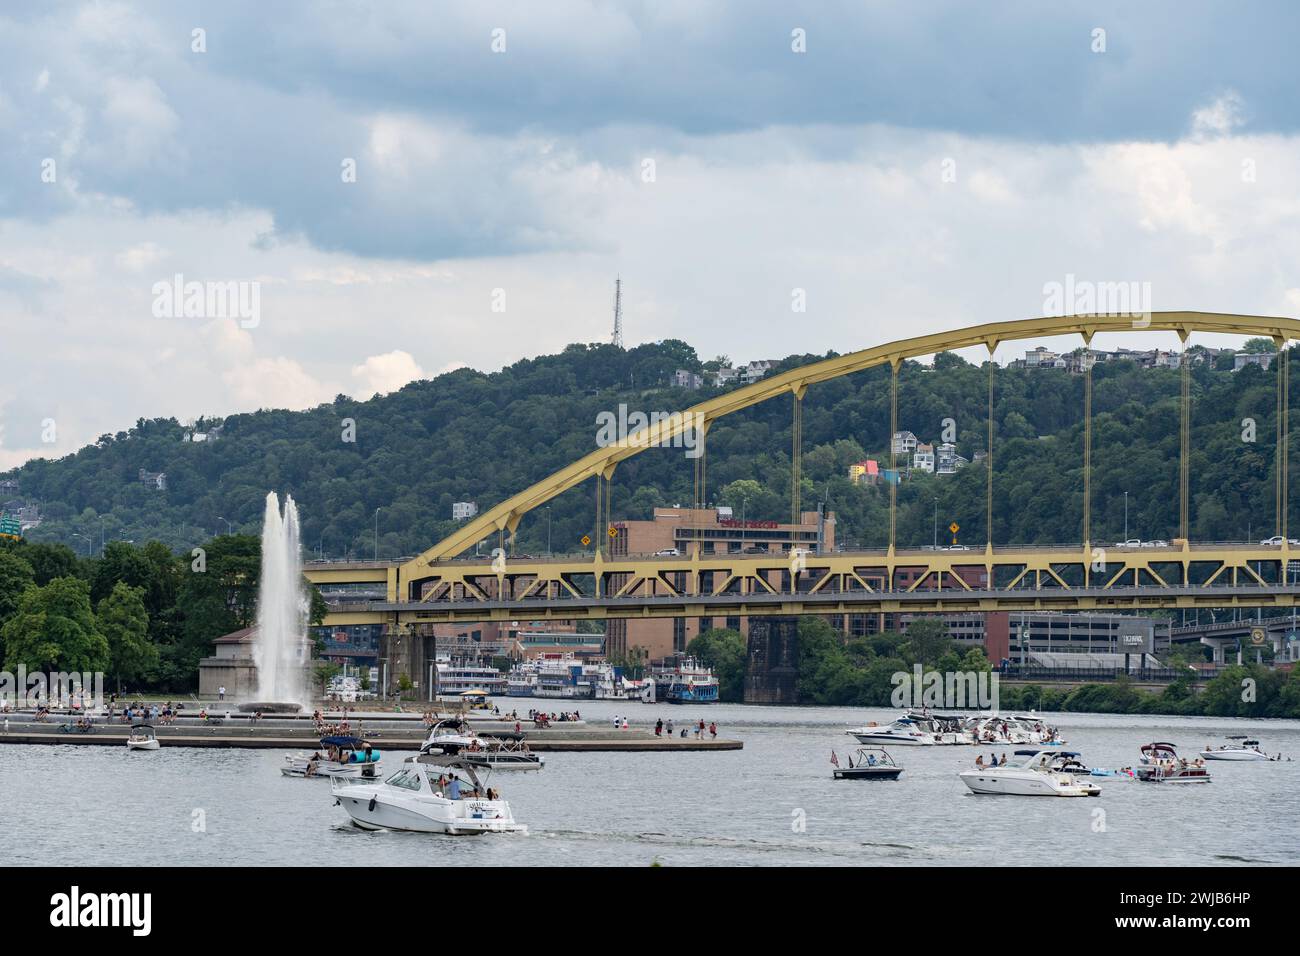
0,700,1300,866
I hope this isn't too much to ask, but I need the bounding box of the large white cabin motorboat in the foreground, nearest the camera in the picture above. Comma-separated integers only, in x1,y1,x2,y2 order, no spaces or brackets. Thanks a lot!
330,753,528,836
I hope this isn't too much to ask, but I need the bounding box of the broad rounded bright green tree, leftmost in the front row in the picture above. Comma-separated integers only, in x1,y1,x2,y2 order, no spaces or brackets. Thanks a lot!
0,578,109,672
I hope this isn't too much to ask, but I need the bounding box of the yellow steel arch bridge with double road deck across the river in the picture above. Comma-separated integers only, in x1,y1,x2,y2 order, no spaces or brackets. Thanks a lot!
307,312,1300,628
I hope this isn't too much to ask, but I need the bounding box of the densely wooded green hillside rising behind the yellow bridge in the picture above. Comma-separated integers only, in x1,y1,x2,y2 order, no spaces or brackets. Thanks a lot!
3,341,1300,558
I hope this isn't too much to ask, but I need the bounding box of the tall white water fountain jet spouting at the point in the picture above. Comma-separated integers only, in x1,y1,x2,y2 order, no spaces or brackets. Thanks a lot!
239,492,311,713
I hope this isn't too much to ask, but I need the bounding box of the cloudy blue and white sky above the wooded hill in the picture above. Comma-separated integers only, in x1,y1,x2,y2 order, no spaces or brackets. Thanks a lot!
0,0,1300,468
